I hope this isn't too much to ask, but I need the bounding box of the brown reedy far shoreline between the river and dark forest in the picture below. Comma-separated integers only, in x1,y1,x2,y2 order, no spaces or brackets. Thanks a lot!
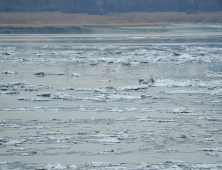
0,12,222,34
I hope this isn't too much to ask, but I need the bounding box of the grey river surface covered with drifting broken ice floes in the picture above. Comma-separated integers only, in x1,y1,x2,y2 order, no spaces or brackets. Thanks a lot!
0,24,222,170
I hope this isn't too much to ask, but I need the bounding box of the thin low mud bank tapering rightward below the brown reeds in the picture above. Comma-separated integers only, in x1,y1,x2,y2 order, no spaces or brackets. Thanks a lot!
0,23,171,34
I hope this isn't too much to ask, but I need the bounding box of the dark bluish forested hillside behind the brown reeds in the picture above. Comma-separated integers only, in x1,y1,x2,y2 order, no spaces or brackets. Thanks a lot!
0,0,222,14
